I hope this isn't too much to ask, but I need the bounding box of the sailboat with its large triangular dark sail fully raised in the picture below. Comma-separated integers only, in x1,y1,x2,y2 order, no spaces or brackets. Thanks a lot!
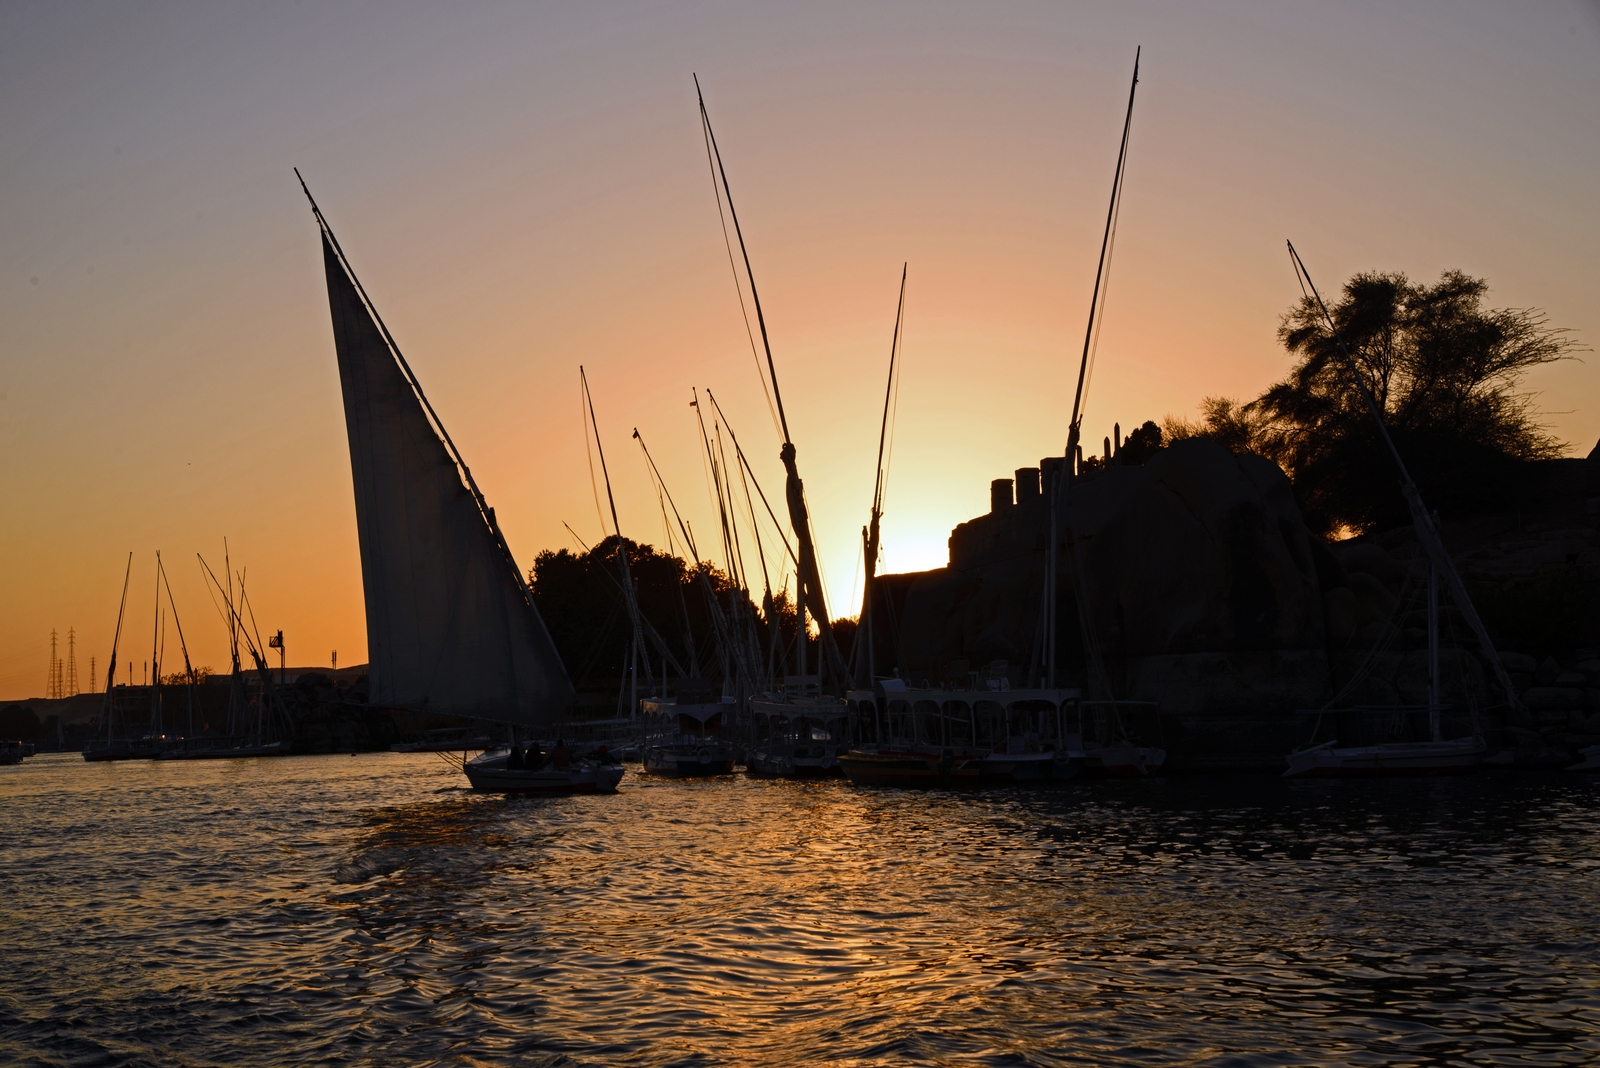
296,171,622,793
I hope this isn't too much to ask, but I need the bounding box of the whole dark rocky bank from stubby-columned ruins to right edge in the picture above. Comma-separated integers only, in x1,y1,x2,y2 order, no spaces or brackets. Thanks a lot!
877,440,1600,769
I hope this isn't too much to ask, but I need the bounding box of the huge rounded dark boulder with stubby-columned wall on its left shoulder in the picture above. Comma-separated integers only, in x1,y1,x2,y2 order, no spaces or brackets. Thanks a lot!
899,440,1350,764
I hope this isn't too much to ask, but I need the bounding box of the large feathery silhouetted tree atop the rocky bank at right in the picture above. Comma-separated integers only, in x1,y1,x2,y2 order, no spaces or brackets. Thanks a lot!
1245,270,1576,531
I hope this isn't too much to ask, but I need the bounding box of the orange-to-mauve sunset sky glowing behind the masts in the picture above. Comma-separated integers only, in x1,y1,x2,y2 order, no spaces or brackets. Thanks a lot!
0,2,1600,699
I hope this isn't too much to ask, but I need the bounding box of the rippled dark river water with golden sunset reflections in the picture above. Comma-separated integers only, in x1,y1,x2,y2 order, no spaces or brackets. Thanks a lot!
0,755,1600,1066
